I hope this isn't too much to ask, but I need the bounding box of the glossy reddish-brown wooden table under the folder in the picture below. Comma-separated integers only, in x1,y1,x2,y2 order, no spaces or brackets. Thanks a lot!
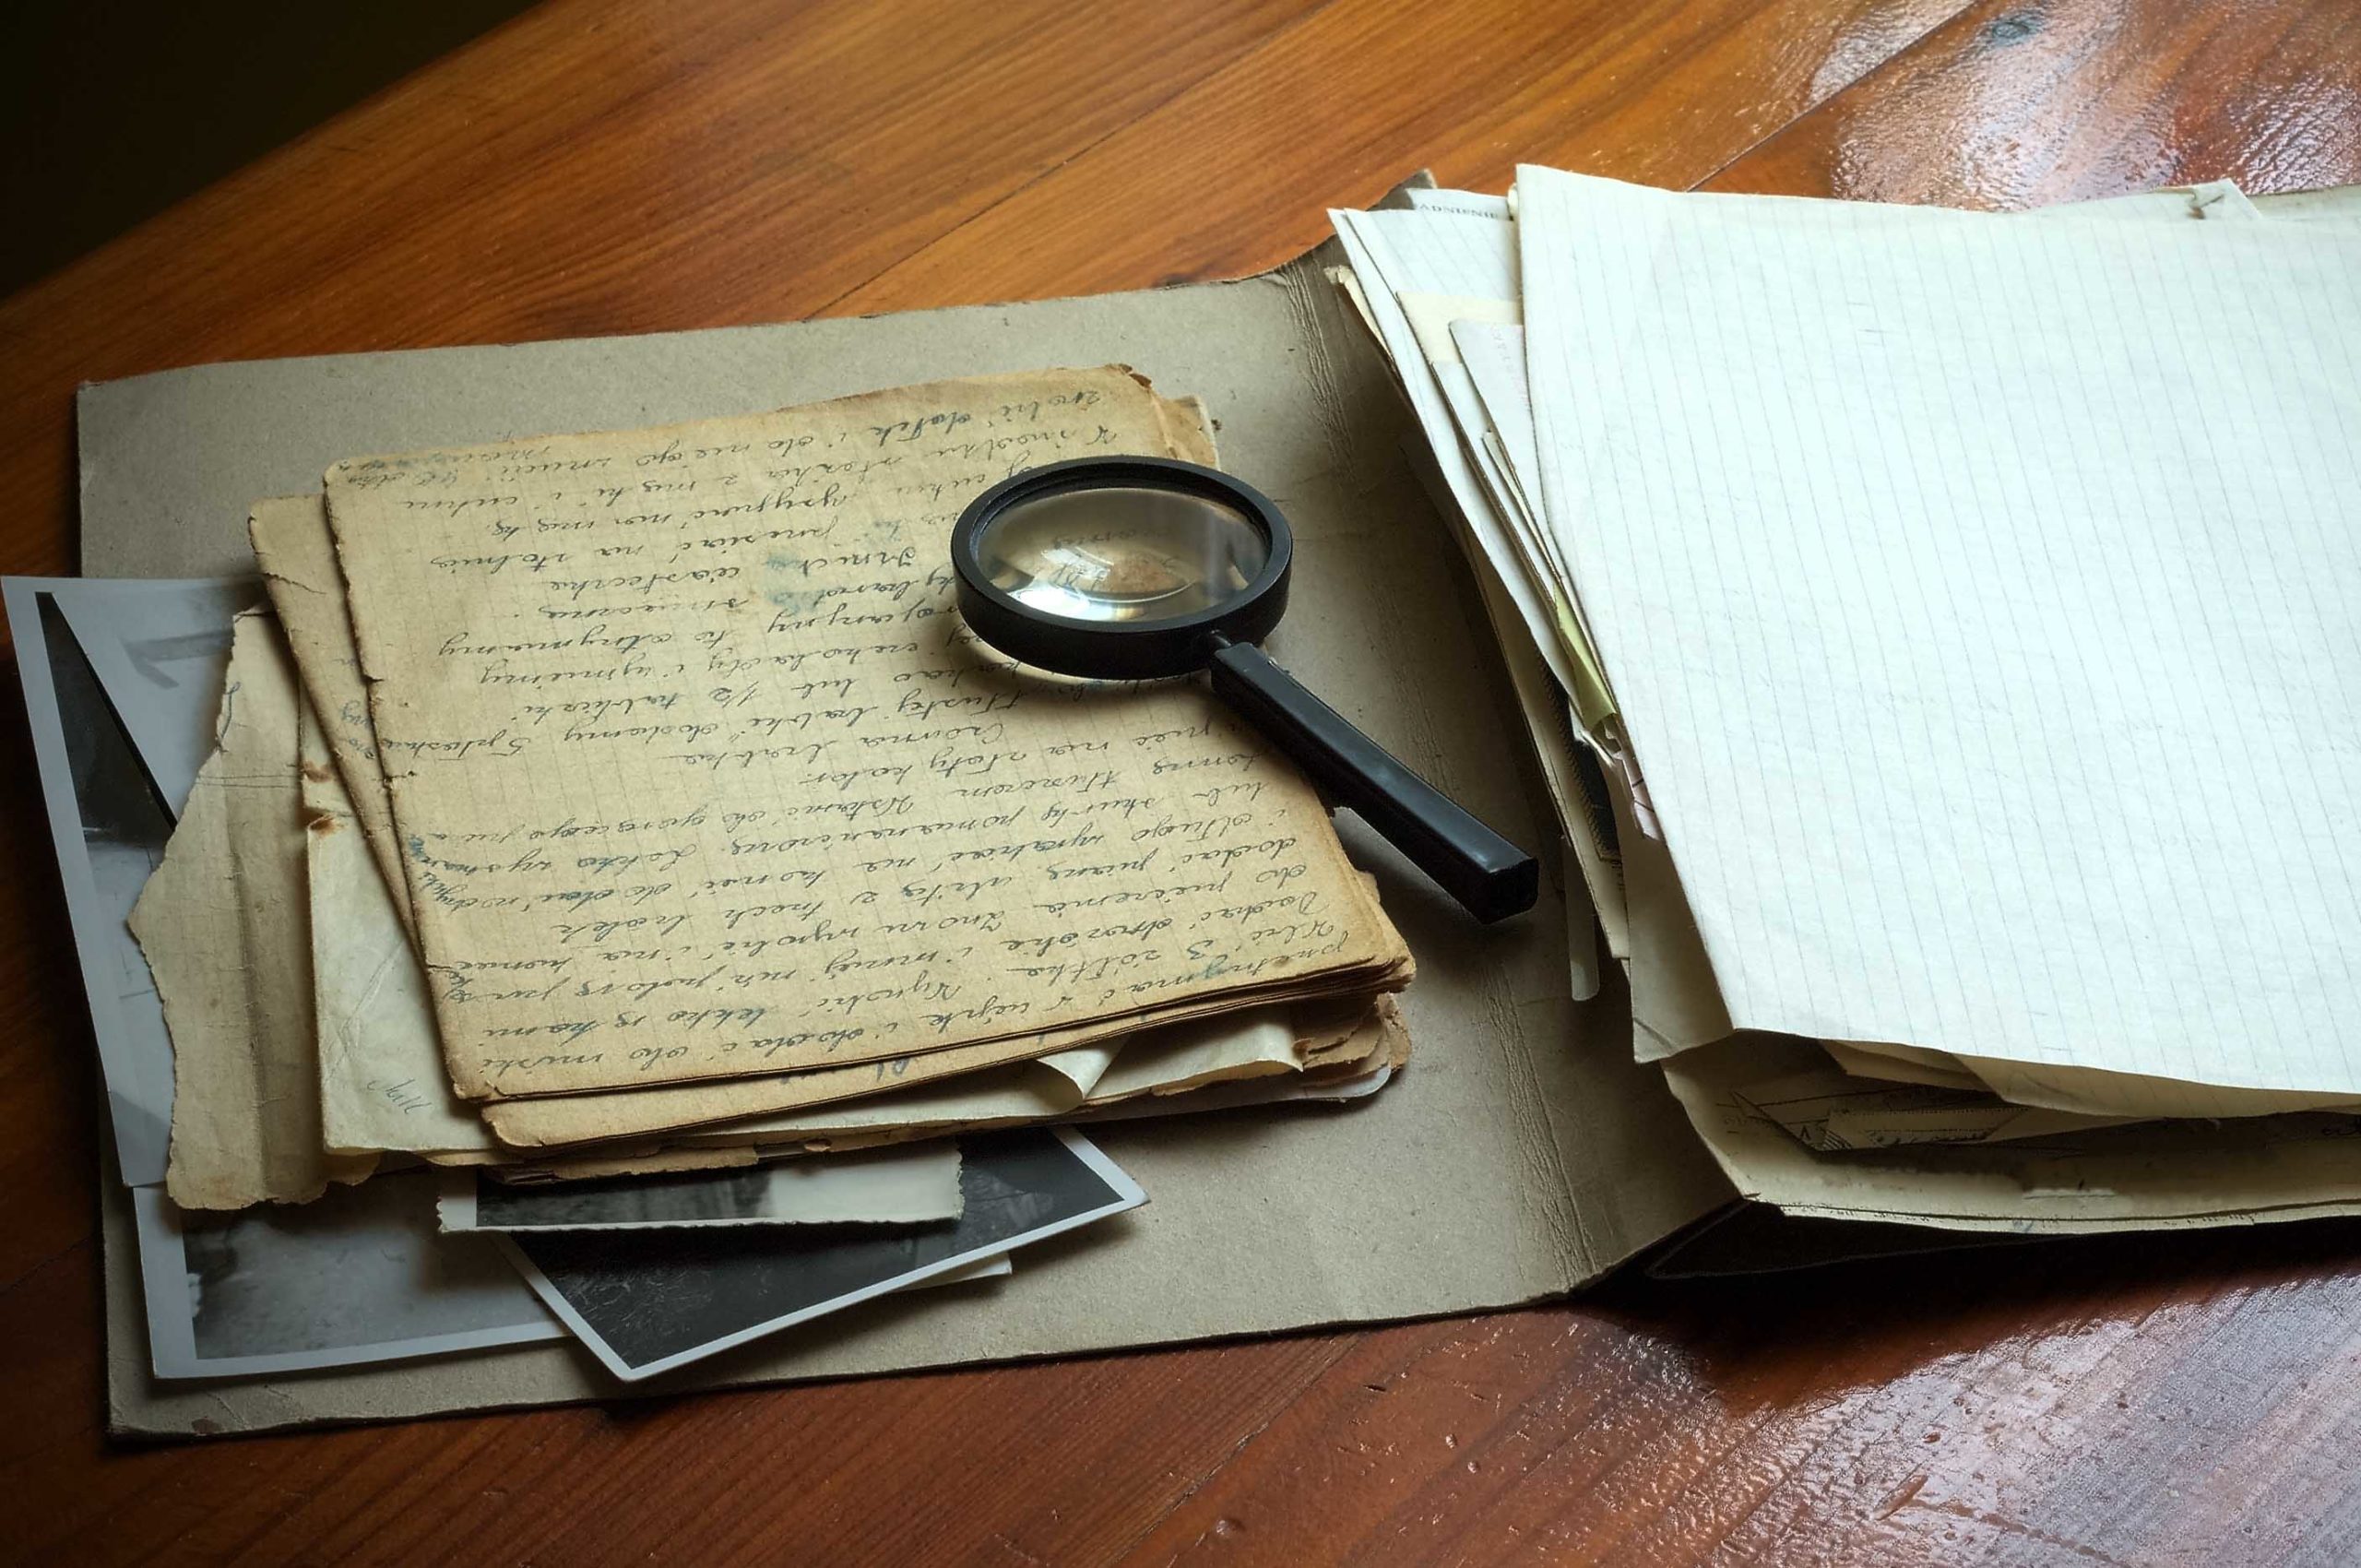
0,0,2361,1568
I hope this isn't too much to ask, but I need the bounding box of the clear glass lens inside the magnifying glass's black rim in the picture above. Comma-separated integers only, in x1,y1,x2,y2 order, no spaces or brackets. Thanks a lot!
975,486,1270,624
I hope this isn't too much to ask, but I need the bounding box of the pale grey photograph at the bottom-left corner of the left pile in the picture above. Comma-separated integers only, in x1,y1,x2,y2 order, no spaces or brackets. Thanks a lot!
132,1171,564,1377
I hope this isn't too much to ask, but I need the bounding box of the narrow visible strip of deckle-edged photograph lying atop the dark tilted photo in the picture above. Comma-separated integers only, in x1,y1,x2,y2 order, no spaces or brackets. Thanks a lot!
442,1138,961,1230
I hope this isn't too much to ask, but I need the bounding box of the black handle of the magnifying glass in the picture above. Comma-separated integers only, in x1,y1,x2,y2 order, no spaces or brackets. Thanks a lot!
1211,642,1542,921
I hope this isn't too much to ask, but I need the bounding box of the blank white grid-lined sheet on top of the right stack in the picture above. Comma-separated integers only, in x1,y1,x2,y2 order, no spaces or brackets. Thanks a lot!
1518,170,2361,1091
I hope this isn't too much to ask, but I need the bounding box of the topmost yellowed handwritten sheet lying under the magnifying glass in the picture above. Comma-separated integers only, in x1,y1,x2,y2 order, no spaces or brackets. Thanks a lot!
328,368,1400,1100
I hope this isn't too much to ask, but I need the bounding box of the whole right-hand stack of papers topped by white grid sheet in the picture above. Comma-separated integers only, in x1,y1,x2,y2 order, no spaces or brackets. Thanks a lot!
1334,168,2361,1230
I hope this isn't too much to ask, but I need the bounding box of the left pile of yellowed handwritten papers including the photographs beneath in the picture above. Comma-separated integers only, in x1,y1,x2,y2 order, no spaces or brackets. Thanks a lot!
9,366,1412,1377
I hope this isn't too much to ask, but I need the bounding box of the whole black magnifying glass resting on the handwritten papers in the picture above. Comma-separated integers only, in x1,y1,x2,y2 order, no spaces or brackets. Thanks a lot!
952,458,1539,921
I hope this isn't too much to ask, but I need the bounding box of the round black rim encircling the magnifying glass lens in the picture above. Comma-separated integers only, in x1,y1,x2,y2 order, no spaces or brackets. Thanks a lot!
952,456,1296,680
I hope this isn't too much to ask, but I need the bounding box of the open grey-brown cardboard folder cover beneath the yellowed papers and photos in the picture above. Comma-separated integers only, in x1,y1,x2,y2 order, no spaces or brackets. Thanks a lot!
80,242,1730,1433
